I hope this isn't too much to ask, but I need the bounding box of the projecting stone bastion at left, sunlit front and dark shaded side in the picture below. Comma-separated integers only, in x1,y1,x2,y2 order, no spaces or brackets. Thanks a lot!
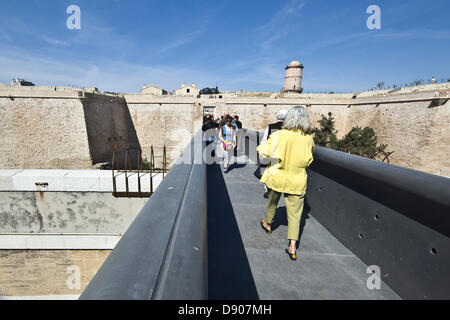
0,87,139,169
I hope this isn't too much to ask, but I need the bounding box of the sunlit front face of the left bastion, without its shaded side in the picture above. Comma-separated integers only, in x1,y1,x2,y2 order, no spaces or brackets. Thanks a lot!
0,97,92,169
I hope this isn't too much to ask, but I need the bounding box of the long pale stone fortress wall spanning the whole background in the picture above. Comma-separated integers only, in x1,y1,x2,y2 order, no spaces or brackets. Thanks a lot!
0,84,450,176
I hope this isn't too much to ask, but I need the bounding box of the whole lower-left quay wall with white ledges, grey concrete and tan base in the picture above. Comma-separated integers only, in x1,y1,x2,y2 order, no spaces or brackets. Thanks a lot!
0,170,151,300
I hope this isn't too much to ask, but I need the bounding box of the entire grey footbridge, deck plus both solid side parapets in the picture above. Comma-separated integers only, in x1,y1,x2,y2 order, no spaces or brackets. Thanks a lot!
80,130,450,300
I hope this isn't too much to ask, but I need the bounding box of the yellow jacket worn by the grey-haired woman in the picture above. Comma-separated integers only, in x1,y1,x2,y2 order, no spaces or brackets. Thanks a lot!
256,130,314,195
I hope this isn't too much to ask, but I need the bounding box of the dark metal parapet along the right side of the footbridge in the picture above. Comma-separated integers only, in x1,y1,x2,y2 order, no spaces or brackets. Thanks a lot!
246,130,450,299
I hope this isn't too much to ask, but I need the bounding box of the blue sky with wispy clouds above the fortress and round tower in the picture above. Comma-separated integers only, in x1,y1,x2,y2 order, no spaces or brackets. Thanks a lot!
0,0,450,92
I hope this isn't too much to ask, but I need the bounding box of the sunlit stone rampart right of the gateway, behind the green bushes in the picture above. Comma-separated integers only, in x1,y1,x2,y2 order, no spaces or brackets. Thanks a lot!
214,100,450,177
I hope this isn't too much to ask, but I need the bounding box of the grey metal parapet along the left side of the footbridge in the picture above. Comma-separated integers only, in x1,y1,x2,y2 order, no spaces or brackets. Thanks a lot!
80,131,208,300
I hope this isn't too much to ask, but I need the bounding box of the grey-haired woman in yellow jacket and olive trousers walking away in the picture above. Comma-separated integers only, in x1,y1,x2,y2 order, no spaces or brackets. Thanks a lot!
257,106,314,260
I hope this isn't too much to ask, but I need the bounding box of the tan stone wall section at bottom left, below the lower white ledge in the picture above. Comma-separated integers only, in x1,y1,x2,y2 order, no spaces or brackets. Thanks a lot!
0,250,111,299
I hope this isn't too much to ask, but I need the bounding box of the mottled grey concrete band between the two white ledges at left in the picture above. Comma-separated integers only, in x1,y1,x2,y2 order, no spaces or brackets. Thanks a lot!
0,192,147,234
